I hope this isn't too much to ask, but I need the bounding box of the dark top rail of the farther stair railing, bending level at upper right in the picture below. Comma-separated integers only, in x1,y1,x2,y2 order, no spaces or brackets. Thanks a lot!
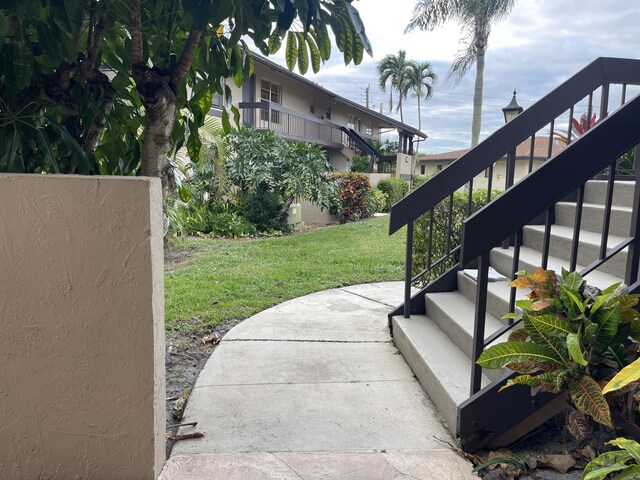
389,57,640,234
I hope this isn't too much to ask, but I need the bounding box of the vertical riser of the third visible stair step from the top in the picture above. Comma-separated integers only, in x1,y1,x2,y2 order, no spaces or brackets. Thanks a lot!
524,227,627,277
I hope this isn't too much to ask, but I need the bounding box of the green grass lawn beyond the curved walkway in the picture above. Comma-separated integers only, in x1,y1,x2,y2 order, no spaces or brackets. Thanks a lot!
165,217,405,332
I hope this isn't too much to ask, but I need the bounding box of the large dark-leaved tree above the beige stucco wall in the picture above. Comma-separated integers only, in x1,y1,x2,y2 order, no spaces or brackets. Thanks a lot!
0,0,371,195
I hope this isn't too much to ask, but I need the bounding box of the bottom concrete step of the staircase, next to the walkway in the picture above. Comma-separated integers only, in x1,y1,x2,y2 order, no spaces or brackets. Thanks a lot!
392,315,490,432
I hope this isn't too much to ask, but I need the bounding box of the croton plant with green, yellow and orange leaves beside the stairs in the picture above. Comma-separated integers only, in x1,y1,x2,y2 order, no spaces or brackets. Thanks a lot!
478,269,640,439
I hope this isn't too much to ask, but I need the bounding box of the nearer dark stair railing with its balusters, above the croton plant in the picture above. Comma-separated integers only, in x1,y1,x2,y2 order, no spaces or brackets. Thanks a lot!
460,95,640,395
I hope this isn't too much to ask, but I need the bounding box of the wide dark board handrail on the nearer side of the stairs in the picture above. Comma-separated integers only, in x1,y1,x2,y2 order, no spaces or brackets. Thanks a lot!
462,95,640,265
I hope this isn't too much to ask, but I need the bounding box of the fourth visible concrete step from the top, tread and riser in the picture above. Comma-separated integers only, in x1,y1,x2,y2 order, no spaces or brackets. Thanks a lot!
490,246,621,290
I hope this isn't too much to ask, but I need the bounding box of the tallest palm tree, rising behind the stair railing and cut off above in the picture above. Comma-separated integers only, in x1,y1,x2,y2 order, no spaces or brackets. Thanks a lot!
405,0,516,147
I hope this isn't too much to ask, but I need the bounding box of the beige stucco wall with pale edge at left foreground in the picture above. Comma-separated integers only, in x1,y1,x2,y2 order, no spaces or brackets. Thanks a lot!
0,175,165,480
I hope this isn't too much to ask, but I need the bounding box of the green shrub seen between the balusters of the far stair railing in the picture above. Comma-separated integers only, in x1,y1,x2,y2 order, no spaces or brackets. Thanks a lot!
412,190,500,285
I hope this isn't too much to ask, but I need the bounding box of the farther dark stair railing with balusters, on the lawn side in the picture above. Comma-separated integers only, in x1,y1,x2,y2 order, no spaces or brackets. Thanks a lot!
389,58,640,317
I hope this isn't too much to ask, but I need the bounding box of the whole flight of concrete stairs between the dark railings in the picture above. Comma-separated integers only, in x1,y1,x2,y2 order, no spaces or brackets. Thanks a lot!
392,181,635,446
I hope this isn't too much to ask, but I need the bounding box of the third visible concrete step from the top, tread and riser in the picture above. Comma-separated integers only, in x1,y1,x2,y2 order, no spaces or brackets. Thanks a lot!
522,225,627,276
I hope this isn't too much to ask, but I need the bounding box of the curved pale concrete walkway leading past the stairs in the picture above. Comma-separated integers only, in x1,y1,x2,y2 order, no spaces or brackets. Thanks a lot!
160,282,475,480
